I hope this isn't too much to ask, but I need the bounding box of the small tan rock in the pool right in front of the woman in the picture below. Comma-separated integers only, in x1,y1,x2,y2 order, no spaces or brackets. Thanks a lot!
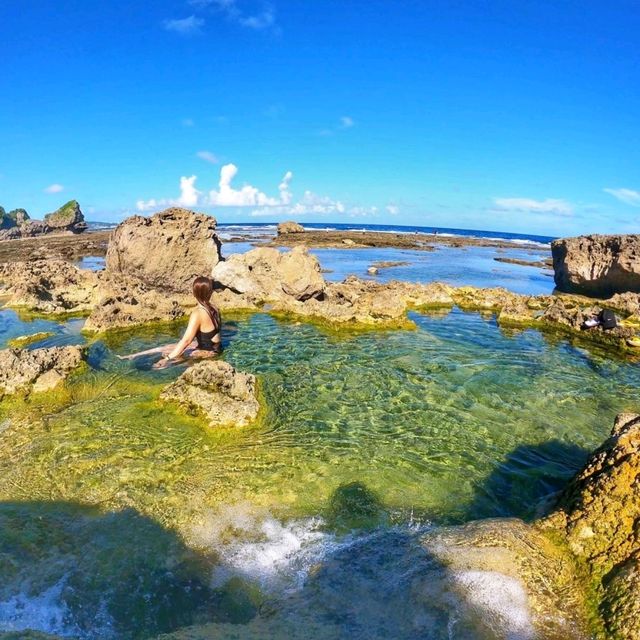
160,360,260,427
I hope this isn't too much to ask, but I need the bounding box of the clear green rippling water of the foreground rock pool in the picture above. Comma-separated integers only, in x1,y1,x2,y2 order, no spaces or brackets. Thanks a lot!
0,311,640,638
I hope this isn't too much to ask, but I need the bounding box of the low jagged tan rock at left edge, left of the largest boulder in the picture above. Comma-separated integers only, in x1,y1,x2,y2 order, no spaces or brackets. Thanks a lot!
0,260,98,314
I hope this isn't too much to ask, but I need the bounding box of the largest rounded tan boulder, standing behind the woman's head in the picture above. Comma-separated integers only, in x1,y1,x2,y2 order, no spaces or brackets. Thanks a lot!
106,208,220,293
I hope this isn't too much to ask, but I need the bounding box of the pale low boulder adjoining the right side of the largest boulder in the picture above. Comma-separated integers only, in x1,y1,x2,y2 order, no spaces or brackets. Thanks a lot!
211,247,326,301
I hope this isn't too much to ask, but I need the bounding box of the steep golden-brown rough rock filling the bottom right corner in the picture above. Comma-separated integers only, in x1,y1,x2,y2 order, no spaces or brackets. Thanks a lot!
541,414,640,640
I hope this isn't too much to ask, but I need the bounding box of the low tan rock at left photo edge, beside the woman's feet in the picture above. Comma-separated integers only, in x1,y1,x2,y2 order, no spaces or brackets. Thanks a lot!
0,347,83,394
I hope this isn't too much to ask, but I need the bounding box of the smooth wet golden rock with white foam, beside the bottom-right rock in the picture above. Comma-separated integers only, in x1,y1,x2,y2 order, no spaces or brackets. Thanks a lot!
423,518,591,640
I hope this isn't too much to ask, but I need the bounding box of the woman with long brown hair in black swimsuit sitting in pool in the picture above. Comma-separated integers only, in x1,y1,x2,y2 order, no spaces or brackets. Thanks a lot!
120,276,222,369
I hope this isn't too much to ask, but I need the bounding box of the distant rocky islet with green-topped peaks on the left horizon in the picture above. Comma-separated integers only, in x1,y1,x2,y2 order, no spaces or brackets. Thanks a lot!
0,200,87,240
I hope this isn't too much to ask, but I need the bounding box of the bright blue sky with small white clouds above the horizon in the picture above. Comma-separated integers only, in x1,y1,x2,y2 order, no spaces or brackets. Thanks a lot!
0,0,640,235
